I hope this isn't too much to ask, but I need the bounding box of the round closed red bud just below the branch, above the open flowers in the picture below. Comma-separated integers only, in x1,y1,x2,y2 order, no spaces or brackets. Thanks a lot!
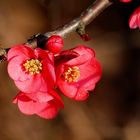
45,35,64,53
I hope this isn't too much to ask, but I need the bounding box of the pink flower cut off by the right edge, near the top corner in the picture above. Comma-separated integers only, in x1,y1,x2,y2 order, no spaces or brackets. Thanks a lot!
129,6,140,29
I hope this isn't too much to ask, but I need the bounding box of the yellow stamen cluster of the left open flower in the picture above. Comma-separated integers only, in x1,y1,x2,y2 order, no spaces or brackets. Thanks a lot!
23,59,42,75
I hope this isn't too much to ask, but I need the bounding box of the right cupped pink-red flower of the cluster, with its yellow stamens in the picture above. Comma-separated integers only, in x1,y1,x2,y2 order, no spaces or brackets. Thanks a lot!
56,45,101,100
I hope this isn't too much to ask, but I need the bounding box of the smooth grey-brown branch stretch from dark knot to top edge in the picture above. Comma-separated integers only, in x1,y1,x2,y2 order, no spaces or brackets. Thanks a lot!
45,0,112,37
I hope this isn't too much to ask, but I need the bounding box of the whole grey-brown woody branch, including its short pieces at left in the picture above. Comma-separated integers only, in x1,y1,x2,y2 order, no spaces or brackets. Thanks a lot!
0,0,112,62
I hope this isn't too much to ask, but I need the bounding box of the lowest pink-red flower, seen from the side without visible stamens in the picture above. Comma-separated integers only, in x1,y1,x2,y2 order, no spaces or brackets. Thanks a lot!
13,90,64,119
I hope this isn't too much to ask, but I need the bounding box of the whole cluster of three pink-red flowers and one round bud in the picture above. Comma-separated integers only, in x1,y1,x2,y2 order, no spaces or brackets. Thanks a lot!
8,35,102,119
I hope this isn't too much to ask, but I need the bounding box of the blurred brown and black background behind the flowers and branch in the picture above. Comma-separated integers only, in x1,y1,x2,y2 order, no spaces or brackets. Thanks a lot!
0,0,140,140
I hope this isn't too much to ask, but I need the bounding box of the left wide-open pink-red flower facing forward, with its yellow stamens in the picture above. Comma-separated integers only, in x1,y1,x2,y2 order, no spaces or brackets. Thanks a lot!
8,45,56,93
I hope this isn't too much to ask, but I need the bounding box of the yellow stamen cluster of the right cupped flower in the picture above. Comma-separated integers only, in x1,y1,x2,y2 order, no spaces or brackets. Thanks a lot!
64,66,80,83
